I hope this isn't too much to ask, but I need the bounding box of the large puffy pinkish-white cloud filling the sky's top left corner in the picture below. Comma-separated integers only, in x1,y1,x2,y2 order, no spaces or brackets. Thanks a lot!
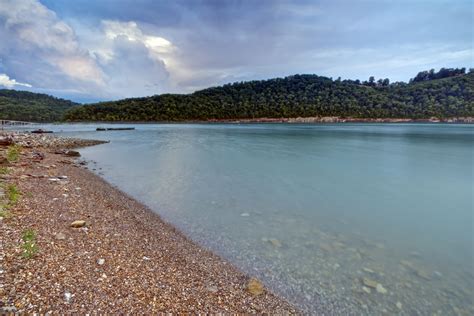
0,0,104,85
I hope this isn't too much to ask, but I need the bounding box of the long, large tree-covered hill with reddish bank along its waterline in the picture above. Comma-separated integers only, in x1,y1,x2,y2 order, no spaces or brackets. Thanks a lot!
65,69,474,121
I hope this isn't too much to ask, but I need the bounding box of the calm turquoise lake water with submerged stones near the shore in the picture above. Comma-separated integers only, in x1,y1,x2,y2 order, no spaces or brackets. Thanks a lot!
18,124,474,315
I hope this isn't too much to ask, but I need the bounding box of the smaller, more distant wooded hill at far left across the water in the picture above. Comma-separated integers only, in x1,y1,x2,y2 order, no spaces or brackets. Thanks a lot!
0,89,78,122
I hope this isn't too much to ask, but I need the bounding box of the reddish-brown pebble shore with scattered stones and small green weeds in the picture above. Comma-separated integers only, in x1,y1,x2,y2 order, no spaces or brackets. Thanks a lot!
0,134,297,314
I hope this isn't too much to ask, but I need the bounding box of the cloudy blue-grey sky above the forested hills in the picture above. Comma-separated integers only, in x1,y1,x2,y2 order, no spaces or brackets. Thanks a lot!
0,0,474,103
